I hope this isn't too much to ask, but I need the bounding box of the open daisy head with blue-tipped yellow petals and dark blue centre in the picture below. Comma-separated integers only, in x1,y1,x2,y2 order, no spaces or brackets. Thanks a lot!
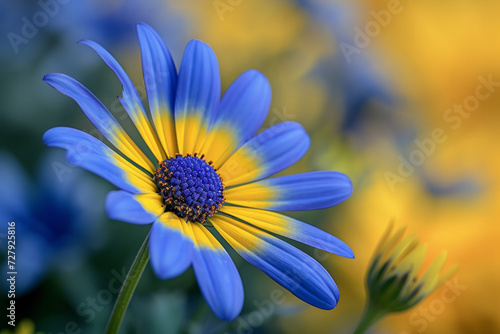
43,24,354,320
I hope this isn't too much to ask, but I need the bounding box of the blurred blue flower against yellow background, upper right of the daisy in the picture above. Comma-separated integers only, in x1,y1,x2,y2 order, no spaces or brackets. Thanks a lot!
296,0,396,131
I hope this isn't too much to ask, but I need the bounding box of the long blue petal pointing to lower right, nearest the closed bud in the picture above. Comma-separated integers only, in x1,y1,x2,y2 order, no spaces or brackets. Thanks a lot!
211,215,339,310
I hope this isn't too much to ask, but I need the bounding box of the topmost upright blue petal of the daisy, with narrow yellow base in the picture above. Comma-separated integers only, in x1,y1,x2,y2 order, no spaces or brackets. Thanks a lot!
137,23,177,156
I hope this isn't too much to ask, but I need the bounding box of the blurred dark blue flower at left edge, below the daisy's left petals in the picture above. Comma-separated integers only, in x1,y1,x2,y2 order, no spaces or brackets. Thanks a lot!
0,151,104,294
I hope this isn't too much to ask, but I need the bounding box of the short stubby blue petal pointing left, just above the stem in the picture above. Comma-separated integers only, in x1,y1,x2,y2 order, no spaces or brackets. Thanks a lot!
106,191,165,224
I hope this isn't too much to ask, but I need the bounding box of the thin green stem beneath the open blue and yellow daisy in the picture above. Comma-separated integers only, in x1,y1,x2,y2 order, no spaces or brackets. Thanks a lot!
106,234,149,334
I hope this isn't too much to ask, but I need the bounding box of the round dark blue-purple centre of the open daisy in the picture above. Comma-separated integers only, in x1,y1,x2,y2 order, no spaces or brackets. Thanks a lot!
154,154,225,223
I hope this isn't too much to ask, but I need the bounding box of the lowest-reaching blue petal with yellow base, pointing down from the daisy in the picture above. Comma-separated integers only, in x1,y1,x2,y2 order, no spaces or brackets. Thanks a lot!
190,223,244,321
